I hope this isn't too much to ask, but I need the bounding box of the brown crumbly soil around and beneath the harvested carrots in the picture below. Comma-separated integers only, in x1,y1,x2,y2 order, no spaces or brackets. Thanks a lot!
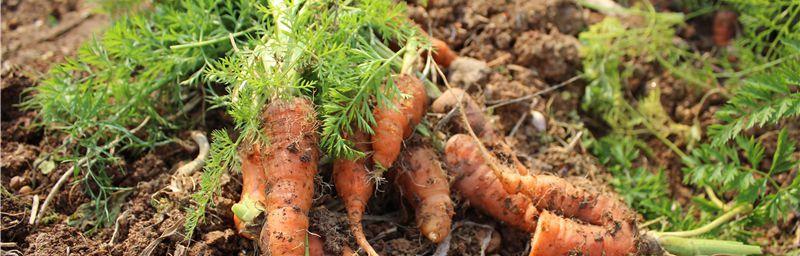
0,0,800,255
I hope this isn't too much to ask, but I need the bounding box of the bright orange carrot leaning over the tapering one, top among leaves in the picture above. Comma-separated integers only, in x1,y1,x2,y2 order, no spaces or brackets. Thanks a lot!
372,74,427,169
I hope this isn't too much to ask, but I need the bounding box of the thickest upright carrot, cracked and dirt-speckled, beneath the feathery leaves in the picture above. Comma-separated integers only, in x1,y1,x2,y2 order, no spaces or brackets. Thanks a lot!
259,98,320,255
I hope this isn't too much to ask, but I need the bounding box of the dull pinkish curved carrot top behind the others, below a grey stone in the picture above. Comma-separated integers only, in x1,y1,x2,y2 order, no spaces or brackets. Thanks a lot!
431,88,496,140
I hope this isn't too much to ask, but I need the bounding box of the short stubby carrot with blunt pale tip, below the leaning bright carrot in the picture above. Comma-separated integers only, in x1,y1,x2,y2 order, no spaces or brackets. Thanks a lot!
396,147,455,243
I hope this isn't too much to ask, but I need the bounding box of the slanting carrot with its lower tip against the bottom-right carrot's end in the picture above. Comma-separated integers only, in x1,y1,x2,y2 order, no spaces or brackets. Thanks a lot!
445,134,539,232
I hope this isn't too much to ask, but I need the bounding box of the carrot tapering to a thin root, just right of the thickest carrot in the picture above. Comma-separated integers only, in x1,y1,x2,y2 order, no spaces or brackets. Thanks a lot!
333,132,378,256
